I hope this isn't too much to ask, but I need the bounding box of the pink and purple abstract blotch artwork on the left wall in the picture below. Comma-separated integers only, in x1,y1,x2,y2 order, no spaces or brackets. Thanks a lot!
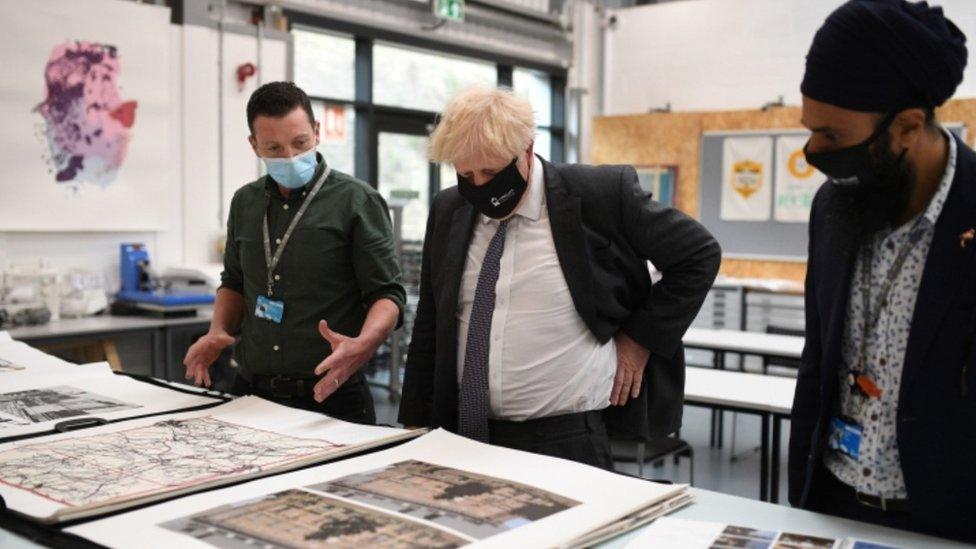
34,41,137,186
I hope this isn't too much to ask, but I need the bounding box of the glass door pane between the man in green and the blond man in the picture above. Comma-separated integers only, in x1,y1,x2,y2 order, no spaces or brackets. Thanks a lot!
378,132,430,241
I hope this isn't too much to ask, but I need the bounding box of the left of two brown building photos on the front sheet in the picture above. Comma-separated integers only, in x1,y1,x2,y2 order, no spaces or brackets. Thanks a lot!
160,490,469,549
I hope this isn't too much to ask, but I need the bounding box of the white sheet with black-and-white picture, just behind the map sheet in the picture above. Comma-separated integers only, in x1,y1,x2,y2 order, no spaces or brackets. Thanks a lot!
0,362,219,439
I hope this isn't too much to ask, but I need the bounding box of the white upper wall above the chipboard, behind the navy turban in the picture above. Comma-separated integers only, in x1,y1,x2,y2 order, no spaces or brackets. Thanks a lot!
602,0,976,115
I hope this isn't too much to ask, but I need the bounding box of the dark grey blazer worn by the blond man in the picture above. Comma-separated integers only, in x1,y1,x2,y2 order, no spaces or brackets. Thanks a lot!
399,156,721,439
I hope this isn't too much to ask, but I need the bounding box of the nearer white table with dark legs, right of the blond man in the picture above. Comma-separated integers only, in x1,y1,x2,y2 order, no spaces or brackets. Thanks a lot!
685,368,796,503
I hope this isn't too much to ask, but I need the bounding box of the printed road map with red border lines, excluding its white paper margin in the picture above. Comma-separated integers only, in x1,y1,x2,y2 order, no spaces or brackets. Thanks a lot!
0,417,343,507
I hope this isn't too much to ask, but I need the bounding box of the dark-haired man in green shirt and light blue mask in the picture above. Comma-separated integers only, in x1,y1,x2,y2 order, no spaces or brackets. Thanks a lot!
184,82,406,423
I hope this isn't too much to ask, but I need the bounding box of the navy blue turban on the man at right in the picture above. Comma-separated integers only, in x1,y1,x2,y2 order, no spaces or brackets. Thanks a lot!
800,0,966,112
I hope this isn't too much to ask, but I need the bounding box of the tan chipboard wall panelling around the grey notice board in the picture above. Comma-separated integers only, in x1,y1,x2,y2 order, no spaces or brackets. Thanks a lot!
592,99,976,282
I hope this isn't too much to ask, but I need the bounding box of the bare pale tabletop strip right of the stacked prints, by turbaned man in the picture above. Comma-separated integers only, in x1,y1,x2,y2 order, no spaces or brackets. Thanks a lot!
604,488,972,549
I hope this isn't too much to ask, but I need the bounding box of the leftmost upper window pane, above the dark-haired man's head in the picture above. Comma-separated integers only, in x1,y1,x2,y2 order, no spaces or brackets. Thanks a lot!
291,29,356,100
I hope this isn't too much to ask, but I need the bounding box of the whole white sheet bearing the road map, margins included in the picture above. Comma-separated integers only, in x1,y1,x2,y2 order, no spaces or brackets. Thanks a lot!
0,396,421,522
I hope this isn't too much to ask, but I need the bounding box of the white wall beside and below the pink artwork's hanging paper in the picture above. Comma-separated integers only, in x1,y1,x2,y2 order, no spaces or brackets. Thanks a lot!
0,5,288,291
